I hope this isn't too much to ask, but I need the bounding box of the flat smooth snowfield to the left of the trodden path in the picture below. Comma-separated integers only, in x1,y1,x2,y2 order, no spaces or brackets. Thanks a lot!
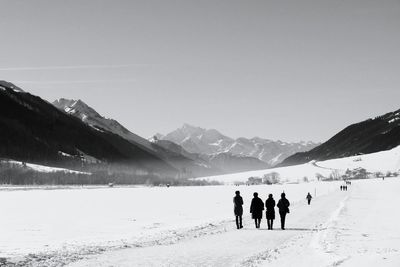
0,182,339,265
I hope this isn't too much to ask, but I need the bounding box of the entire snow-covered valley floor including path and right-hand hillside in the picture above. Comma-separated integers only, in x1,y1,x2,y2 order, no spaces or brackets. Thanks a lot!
0,147,400,266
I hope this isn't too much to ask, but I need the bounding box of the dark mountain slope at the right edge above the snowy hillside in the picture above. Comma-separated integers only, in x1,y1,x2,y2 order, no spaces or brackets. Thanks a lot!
281,109,400,165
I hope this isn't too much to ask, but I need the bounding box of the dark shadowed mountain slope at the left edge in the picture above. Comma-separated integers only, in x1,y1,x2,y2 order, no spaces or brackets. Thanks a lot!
0,81,177,174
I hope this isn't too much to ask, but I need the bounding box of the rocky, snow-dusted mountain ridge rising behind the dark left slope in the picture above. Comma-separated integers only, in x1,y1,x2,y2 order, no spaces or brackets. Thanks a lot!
53,98,220,177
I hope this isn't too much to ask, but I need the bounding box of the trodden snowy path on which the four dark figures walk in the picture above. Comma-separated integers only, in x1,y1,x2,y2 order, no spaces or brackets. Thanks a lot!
70,189,349,266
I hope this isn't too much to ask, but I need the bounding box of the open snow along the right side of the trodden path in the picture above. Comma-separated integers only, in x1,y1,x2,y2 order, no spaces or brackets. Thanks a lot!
262,179,400,267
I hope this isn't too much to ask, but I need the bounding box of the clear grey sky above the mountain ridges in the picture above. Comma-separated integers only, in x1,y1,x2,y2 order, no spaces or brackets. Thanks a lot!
0,0,400,141
